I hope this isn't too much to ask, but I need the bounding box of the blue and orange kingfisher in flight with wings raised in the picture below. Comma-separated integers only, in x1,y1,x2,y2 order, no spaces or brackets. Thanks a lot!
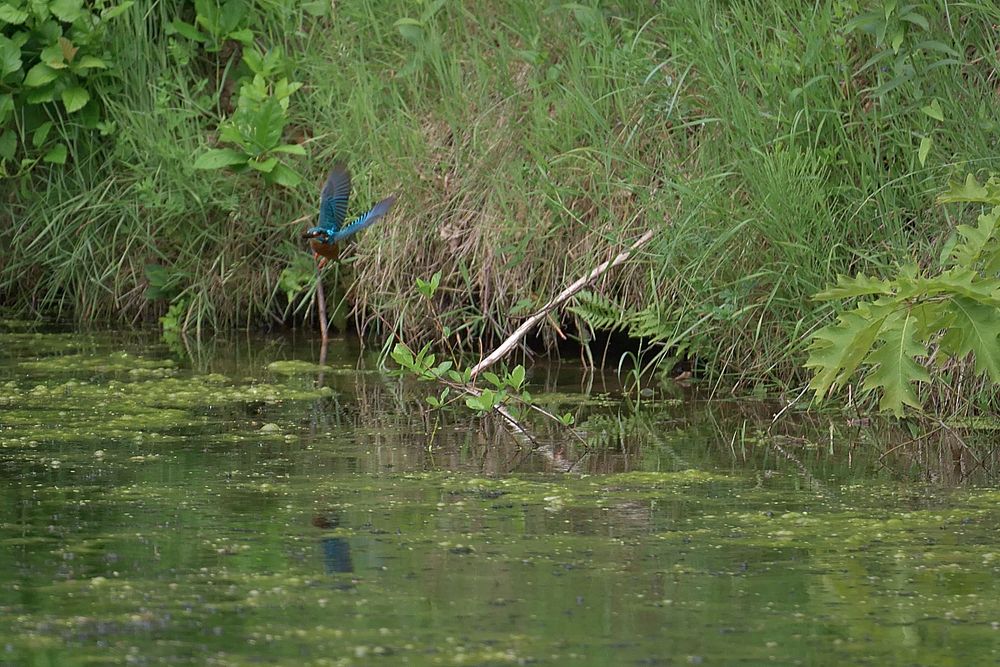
302,164,396,268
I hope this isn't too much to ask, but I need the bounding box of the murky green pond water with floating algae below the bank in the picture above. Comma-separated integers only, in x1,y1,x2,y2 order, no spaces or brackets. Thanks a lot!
0,321,1000,665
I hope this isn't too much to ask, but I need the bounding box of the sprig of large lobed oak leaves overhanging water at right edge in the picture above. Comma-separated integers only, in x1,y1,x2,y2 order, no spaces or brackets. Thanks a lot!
805,174,1000,417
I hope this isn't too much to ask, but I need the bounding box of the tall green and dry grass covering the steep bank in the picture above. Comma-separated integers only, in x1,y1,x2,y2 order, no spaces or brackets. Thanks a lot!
0,0,1000,383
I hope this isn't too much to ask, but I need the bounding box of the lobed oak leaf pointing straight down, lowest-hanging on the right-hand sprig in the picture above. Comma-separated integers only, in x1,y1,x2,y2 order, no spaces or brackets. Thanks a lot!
861,312,930,417
